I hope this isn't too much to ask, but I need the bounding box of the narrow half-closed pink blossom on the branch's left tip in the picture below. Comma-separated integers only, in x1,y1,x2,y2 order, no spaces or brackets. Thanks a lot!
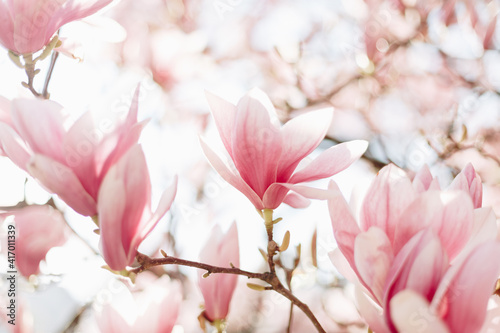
98,144,177,271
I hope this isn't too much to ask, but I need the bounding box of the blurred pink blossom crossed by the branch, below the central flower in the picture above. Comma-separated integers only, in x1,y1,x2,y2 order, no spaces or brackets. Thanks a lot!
198,222,240,322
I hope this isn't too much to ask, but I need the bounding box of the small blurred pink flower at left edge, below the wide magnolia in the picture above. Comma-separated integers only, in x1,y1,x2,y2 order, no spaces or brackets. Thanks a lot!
0,205,67,277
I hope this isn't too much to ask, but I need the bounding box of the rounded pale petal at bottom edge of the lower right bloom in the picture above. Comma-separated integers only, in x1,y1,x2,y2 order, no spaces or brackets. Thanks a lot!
390,290,450,333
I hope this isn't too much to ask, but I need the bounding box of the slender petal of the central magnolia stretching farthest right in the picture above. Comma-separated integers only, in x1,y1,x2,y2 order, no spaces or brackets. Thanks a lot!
288,140,368,184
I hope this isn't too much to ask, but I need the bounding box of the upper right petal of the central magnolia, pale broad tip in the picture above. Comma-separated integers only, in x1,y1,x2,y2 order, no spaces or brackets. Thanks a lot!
277,108,333,182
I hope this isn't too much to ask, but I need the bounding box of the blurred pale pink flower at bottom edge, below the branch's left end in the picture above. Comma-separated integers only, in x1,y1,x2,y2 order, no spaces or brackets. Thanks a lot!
96,274,182,333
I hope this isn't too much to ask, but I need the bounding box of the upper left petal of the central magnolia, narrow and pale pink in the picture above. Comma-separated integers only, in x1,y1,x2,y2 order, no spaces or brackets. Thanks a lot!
205,91,236,158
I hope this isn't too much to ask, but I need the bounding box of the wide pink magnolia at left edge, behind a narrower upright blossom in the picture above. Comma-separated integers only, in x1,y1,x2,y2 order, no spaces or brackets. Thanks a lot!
0,89,145,216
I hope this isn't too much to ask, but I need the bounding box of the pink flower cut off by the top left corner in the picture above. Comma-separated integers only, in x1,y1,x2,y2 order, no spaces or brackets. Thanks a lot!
0,0,112,54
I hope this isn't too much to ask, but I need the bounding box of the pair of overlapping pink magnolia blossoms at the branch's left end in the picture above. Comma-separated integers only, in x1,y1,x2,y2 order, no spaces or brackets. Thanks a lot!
0,90,177,271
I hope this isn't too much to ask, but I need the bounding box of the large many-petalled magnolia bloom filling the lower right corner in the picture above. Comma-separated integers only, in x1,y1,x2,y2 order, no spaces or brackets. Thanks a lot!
328,165,500,333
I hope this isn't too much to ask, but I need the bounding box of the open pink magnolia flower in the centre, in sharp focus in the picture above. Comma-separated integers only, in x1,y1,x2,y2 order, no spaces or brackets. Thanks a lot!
201,89,367,210
